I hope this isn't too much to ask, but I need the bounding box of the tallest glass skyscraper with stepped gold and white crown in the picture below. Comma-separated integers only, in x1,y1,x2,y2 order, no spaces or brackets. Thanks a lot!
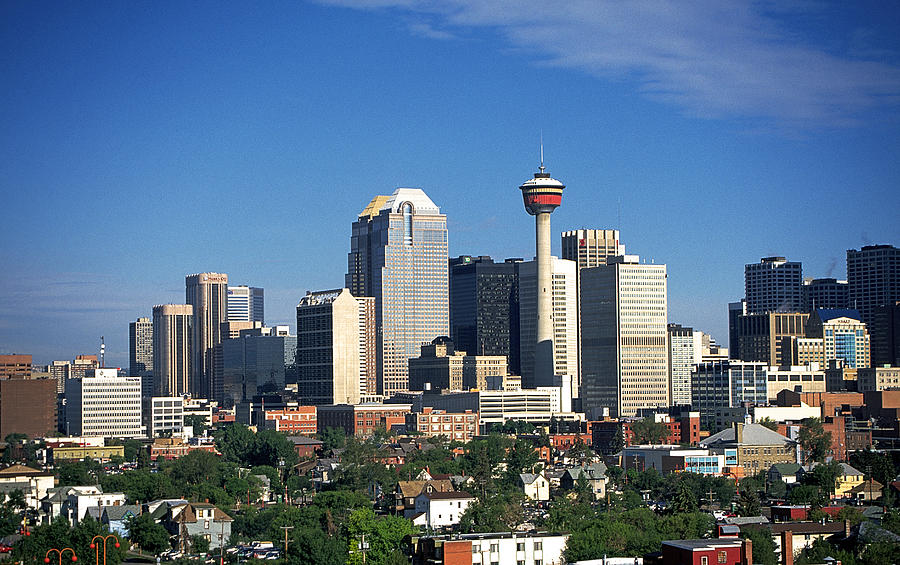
346,188,449,397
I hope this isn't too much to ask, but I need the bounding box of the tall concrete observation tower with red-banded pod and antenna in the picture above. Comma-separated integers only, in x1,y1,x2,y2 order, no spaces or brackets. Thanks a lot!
519,151,566,386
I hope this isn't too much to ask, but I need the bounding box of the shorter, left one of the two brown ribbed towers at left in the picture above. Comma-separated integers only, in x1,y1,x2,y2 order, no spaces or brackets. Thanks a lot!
152,304,194,396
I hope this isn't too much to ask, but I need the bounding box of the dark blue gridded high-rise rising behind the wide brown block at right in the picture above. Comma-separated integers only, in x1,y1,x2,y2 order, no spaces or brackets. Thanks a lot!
744,257,803,314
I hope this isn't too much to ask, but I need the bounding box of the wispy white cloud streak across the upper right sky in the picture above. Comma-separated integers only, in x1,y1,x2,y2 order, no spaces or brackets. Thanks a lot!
320,0,900,128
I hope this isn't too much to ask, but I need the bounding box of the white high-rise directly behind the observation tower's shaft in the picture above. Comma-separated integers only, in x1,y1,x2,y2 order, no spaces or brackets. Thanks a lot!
519,257,580,397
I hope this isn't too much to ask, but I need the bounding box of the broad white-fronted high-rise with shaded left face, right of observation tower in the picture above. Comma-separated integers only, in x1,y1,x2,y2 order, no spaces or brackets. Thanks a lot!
580,255,671,417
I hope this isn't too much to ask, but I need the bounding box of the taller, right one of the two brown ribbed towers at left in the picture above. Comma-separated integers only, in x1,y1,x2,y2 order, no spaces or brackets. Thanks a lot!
184,273,228,398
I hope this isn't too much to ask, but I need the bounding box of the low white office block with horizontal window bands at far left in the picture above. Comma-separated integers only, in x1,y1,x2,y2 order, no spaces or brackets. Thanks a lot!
66,369,145,438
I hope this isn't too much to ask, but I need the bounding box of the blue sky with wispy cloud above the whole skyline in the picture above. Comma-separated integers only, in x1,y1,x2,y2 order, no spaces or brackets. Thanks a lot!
0,0,900,366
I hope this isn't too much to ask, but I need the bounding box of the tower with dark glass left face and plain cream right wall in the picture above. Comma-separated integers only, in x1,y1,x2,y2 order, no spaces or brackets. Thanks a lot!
297,288,366,406
